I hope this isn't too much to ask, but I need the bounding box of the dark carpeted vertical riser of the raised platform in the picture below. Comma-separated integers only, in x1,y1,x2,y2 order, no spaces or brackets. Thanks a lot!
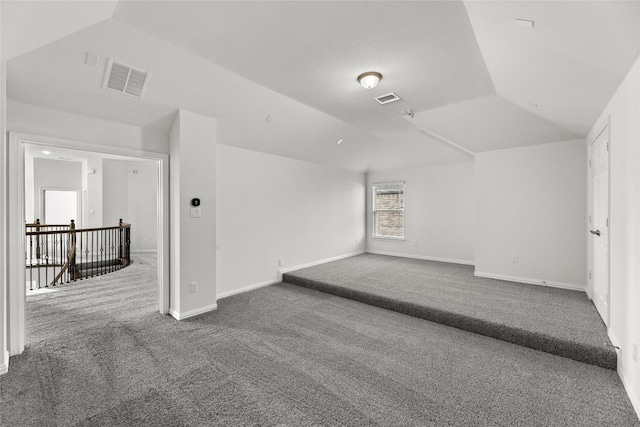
282,273,617,370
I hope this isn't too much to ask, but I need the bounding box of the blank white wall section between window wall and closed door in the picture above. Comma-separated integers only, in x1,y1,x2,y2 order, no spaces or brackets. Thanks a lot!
475,140,587,289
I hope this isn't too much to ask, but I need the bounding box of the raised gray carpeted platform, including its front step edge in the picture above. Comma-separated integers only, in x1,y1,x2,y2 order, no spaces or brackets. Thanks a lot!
283,254,617,369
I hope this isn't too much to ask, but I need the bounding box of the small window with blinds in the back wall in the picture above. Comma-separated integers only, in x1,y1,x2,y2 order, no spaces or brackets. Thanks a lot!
373,182,404,239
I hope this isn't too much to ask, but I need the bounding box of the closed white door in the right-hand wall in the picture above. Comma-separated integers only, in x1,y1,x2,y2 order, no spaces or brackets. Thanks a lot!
589,124,609,326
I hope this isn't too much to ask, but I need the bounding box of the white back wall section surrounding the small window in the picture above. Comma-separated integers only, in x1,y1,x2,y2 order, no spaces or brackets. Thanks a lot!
366,162,475,264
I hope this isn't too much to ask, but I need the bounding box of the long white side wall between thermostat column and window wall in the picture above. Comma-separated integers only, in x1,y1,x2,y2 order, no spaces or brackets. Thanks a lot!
216,144,365,298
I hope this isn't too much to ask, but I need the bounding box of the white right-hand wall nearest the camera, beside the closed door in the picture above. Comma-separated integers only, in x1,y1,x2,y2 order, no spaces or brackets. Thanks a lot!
587,54,640,414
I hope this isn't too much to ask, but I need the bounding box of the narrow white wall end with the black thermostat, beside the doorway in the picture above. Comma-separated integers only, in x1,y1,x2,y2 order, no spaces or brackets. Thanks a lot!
169,110,217,319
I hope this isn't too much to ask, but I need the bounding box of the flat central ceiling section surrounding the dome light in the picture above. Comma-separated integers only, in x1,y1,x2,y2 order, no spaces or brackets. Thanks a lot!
114,1,494,136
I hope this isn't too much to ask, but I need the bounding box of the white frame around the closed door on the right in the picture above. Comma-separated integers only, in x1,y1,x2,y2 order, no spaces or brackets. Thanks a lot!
586,115,611,328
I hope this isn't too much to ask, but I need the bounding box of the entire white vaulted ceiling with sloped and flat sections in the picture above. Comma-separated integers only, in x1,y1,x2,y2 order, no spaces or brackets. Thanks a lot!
1,1,640,171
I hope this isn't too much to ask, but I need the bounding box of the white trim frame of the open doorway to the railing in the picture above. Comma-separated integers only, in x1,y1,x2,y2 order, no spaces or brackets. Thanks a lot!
7,132,169,356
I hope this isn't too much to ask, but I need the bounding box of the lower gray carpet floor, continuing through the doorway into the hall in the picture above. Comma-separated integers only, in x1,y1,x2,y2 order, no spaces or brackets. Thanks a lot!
0,254,640,426
